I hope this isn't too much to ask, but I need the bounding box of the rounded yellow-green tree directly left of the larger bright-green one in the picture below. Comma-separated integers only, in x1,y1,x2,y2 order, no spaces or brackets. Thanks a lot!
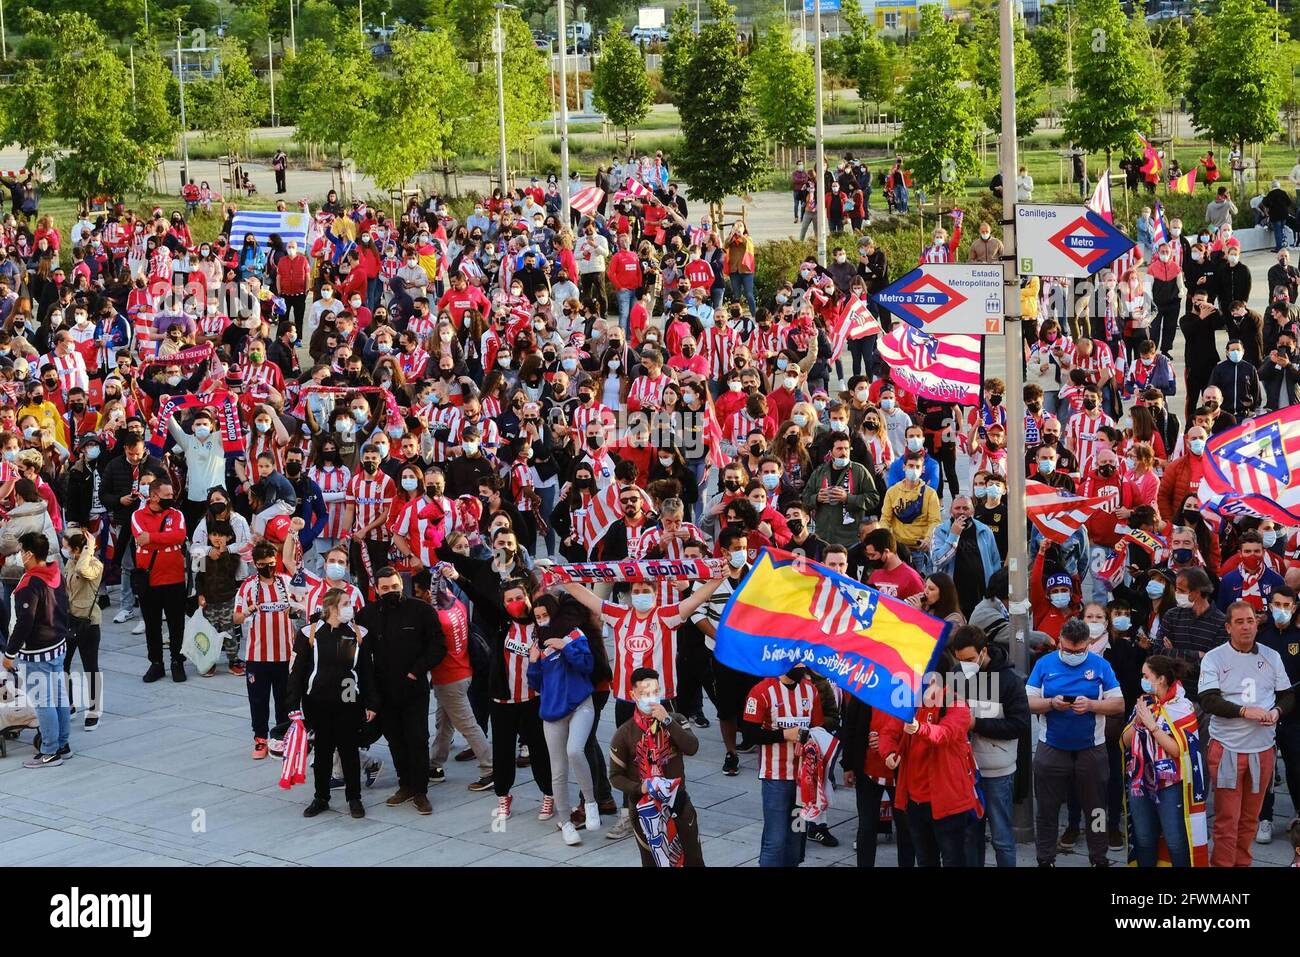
281,30,378,163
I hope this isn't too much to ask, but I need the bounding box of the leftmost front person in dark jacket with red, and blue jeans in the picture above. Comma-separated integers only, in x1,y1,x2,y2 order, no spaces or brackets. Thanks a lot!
4,532,72,768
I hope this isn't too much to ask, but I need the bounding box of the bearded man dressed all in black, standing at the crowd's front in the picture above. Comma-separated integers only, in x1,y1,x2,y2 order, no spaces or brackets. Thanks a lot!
356,566,447,814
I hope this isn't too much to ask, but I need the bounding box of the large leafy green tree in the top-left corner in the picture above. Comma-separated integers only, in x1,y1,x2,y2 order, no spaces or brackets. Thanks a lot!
3,10,157,200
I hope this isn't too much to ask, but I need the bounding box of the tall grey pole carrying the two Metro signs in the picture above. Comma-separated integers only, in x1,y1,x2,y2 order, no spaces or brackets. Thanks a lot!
997,0,1034,841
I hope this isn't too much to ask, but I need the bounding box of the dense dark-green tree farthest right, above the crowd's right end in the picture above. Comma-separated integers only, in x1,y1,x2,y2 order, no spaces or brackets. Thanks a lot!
1188,0,1286,148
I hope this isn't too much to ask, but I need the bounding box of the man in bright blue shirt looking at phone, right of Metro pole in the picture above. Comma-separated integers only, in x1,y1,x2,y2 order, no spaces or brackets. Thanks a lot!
1024,618,1125,867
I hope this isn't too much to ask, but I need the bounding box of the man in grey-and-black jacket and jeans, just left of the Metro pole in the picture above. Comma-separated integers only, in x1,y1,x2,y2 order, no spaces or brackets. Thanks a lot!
948,625,1031,867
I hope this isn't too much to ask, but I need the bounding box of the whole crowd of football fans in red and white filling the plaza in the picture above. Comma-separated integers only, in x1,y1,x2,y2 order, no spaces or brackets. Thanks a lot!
0,147,1300,866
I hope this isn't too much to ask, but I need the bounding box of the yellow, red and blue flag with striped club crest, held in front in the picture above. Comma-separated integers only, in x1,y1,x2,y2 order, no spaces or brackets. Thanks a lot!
714,549,952,722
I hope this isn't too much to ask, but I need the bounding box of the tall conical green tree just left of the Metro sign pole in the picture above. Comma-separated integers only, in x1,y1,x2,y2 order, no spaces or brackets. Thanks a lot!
898,5,979,198
